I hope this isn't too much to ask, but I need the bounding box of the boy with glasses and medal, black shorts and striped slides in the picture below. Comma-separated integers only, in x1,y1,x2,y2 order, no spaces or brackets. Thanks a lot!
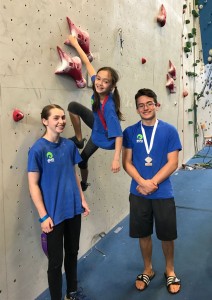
123,89,182,294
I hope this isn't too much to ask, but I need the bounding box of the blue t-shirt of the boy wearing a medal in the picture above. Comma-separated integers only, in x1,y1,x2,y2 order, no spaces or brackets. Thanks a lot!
123,120,182,199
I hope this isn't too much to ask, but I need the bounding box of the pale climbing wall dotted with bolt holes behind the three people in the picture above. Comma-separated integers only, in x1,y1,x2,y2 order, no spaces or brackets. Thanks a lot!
0,0,208,300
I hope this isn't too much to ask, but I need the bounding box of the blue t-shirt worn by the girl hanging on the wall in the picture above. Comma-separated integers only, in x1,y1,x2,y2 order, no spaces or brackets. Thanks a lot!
91,76,123,150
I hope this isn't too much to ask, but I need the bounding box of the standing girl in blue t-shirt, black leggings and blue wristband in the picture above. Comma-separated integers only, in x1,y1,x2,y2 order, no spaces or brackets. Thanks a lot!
28,104,90,300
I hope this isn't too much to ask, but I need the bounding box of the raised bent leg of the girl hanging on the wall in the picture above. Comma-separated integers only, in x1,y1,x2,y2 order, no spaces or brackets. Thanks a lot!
68,102,94,149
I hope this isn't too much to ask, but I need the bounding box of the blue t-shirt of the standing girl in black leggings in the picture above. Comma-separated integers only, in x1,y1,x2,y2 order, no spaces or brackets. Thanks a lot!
28,138,83,225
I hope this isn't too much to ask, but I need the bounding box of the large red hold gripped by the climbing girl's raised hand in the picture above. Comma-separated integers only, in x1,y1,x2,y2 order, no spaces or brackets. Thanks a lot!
65,17,93,62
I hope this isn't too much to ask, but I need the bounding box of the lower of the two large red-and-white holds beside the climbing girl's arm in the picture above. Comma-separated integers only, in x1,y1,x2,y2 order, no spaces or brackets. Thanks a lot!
55,46,86,88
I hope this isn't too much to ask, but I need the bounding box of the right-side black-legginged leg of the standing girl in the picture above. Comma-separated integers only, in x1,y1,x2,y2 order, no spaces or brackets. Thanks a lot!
64,215,81,295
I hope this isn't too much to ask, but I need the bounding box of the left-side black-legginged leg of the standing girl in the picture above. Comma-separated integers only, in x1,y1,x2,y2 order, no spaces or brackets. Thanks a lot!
47,222,64,300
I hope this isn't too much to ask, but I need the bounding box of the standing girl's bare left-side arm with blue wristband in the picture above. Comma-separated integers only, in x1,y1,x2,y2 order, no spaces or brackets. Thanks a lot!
28,172,54,233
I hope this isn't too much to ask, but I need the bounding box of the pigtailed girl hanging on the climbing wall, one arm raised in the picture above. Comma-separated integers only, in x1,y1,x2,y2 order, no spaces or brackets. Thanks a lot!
68,35,123,191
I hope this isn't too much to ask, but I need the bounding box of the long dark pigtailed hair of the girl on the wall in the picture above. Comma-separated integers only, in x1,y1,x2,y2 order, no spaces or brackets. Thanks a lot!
92,67,124,121
